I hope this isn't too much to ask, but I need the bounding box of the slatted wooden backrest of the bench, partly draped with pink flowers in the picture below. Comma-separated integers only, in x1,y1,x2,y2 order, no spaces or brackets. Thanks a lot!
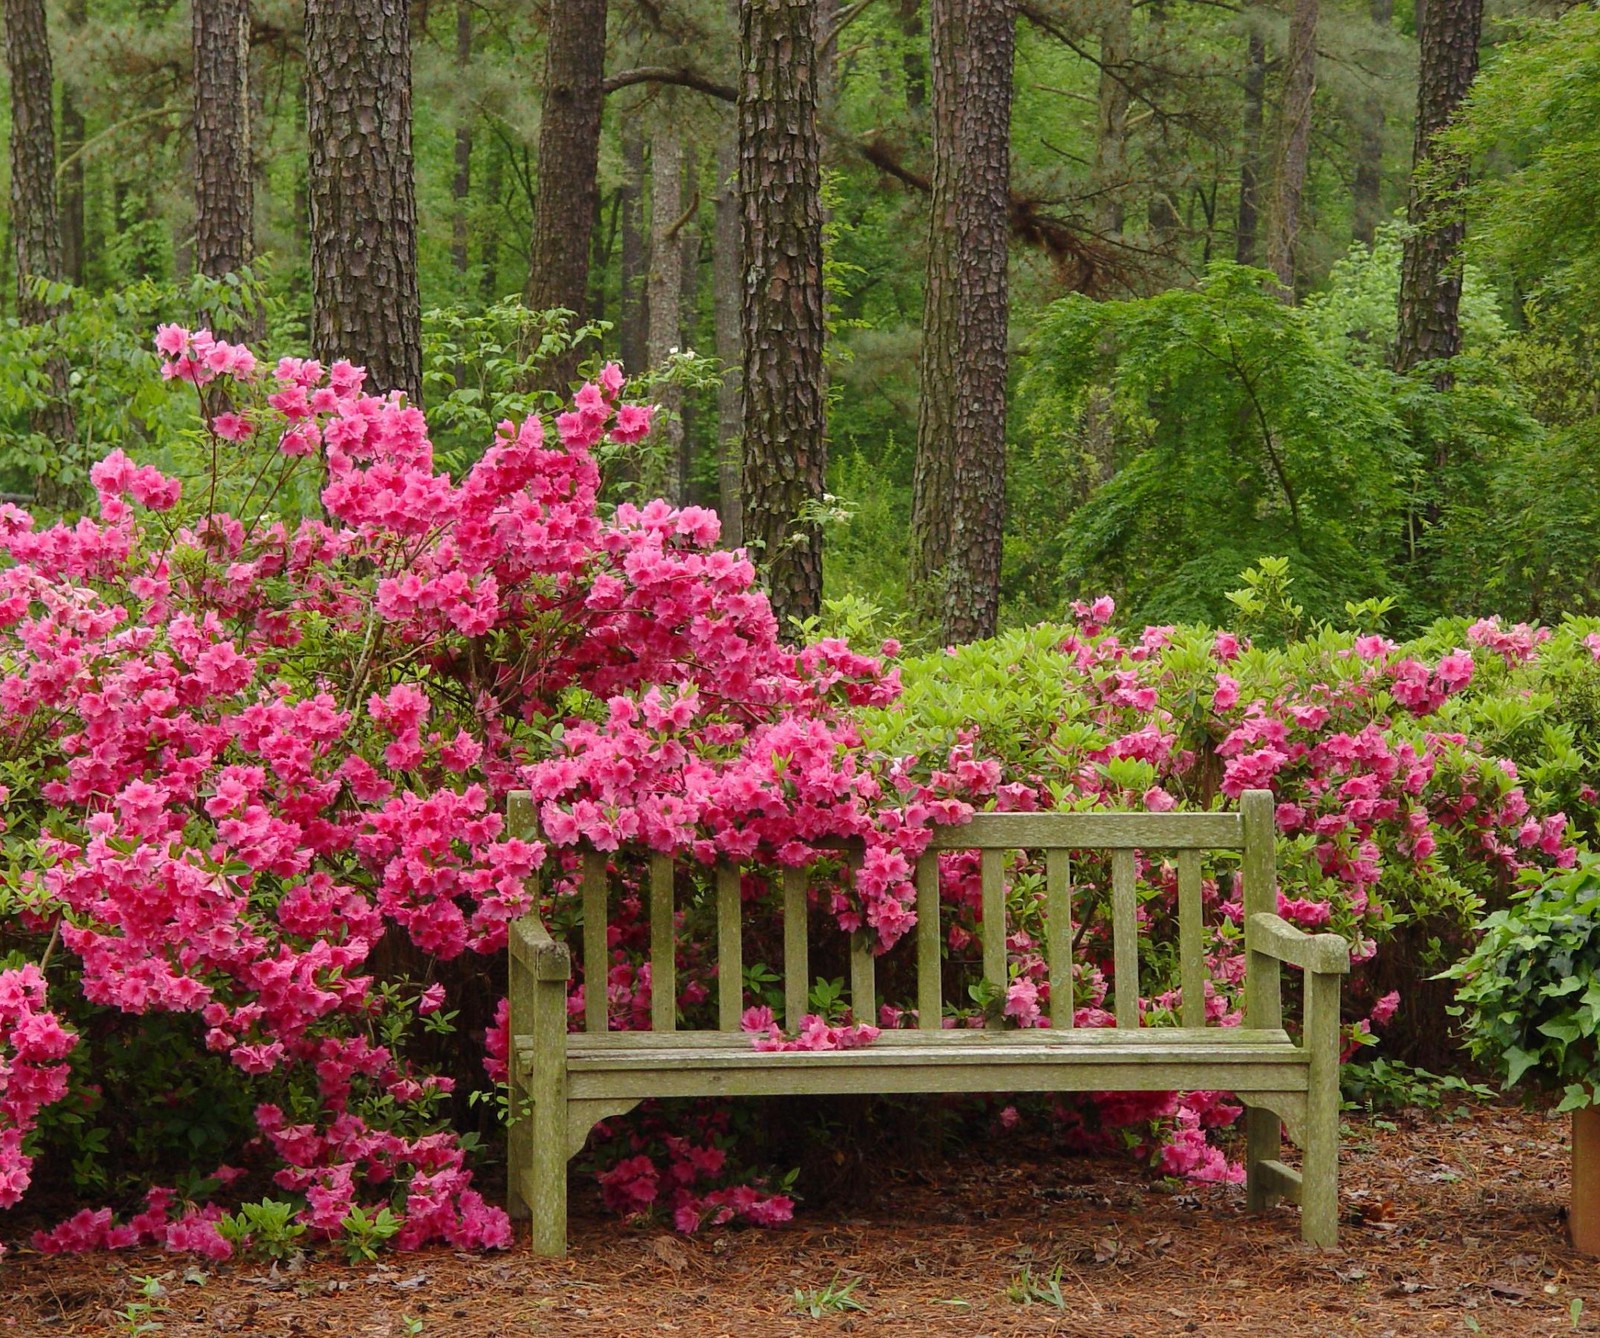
507,791,1278,1032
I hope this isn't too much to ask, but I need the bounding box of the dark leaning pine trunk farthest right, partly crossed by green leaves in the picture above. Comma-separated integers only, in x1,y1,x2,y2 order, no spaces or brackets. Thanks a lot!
1395,0,1483,386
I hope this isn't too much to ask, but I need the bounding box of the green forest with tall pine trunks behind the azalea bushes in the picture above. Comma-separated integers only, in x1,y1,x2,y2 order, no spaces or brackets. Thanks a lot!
0,0,1600,645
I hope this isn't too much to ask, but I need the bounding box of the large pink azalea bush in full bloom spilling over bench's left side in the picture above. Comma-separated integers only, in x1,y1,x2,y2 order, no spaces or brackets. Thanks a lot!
0,326,966,1248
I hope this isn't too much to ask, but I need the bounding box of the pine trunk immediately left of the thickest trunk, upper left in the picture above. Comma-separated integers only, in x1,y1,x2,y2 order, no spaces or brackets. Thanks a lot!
194,0,254,278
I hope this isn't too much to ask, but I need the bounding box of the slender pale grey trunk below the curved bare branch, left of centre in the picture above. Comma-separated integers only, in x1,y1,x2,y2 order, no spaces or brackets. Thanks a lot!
640,120,683,501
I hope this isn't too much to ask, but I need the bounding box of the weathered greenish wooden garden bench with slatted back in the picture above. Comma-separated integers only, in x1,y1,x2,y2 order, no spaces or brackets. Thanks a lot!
509,791,1350,1256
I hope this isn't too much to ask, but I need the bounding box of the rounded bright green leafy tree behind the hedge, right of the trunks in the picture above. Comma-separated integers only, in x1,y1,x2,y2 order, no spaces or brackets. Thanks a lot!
1018,264,1411,623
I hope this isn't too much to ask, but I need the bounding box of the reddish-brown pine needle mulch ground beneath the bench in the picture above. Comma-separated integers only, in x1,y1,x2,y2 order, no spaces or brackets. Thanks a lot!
0,1106,1600,1338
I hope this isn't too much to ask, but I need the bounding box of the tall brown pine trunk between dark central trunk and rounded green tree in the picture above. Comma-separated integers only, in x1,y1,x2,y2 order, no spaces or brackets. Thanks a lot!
910,0,1016,643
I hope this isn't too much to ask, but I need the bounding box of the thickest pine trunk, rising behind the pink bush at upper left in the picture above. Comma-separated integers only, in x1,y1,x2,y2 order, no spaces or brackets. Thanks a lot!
306,0,422,402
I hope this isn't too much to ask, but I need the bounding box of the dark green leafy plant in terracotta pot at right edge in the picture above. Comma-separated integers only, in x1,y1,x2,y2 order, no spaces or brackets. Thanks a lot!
1443,853,1600,1111
